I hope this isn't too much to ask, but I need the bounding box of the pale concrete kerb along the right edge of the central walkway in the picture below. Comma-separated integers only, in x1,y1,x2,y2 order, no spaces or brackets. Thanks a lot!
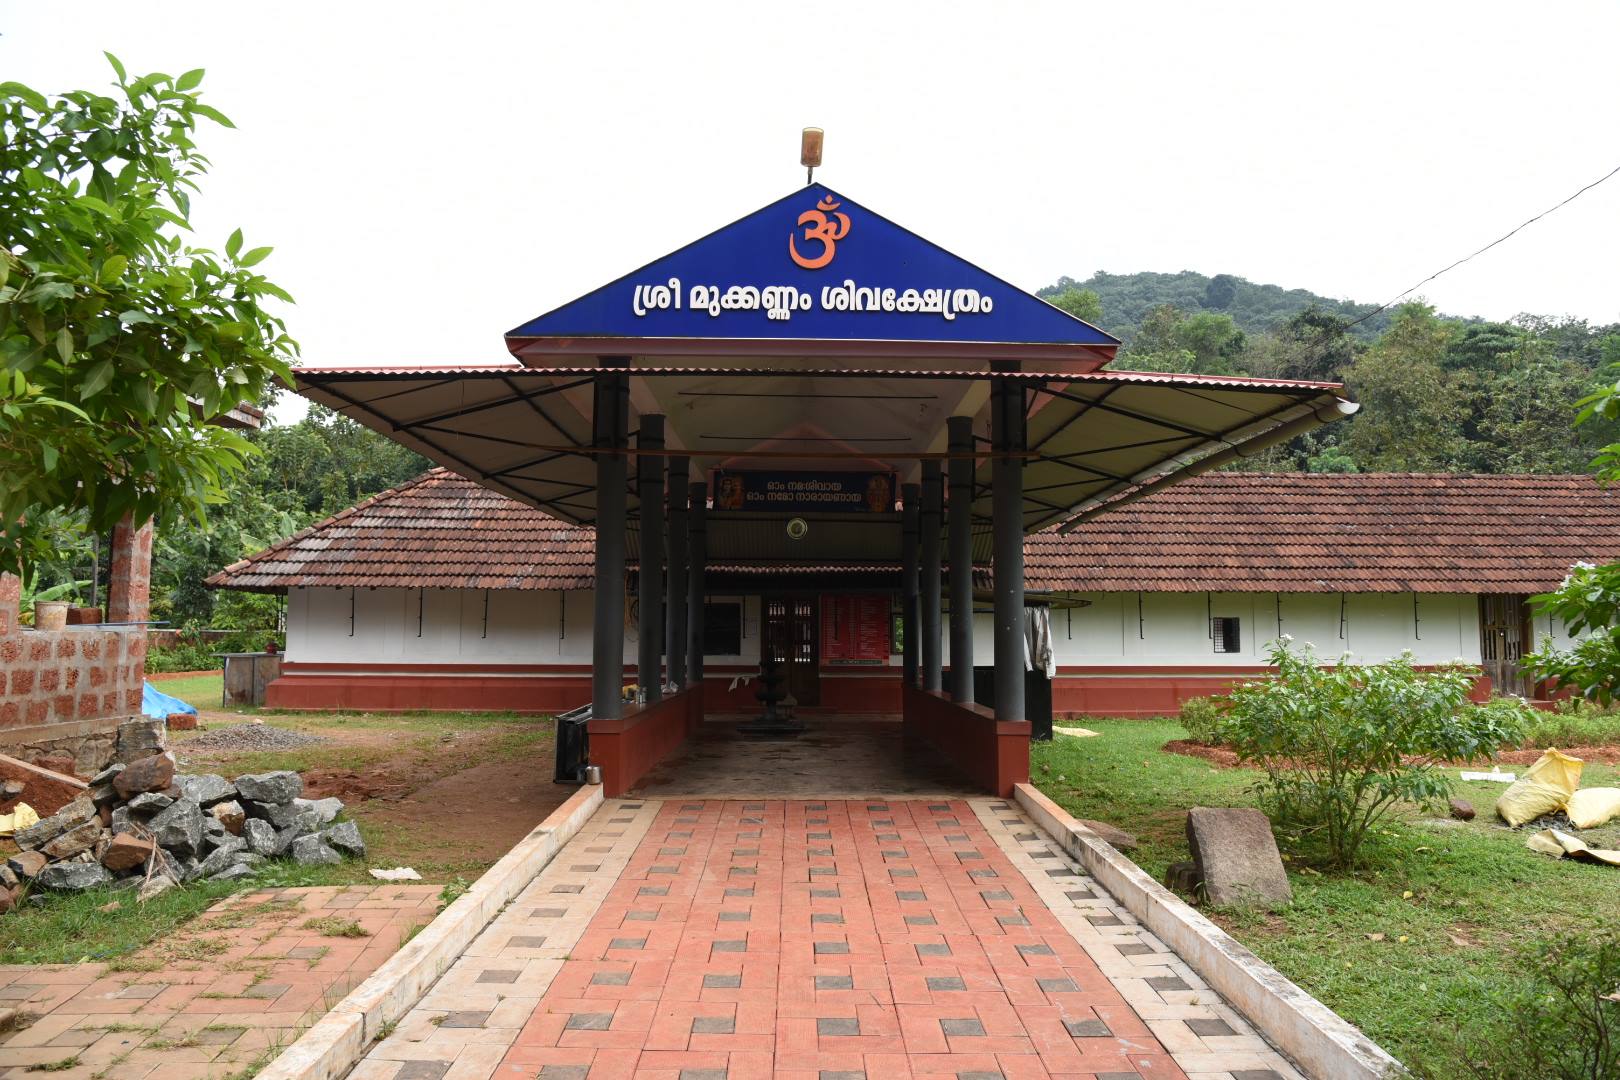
1013,784,1406,1080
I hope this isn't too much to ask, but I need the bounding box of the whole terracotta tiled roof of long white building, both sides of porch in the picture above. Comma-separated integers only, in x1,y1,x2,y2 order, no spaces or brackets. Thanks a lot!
209,470,1620,593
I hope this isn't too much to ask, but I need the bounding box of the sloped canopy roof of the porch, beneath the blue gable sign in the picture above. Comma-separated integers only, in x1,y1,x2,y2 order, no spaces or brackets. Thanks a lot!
298,364,1354,562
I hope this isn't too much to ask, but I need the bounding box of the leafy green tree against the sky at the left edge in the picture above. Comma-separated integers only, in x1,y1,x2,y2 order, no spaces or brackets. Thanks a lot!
0,53,296,582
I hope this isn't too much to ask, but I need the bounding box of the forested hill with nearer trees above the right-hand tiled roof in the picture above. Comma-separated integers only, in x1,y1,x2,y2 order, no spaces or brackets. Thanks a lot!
1040,270,1620,473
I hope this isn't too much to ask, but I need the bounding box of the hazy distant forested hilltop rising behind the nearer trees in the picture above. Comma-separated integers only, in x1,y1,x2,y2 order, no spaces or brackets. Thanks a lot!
1040,270,1390,343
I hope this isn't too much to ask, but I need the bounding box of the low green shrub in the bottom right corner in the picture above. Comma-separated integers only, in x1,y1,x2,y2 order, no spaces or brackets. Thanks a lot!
1416,926,1620,1080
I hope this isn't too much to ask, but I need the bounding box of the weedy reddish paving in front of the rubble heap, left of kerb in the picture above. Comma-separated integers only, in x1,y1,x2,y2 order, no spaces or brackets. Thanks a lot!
0,886,439,1080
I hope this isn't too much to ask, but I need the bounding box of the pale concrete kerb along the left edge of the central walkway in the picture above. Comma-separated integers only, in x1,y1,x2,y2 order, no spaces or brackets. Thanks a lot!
258,784,603,1080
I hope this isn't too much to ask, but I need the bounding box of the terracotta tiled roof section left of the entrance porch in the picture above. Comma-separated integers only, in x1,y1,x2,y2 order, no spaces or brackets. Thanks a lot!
207,468,596,593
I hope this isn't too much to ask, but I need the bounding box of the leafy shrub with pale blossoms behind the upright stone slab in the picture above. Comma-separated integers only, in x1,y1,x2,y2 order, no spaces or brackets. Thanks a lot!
1217,635,1528,868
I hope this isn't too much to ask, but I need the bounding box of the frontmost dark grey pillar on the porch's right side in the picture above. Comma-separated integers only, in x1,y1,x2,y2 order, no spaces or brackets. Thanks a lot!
990,379,1027,721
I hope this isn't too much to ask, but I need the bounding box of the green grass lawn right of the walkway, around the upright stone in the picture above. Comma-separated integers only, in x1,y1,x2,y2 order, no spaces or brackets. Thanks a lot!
1030,719,1620,1077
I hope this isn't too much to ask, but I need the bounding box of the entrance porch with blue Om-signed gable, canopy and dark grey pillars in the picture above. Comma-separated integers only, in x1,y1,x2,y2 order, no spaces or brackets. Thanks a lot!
296,185,1356,795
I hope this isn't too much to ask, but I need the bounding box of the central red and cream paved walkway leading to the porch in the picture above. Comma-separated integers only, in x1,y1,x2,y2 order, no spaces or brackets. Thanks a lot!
350,798,1299,1080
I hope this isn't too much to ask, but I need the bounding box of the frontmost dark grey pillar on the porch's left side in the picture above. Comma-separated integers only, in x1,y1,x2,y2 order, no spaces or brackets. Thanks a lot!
591,371,630,719
